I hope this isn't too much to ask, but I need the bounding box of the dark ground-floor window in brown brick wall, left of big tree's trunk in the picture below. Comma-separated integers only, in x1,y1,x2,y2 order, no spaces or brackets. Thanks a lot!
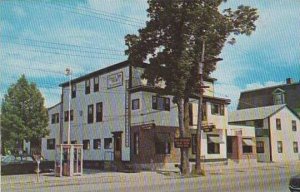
155,133,171,154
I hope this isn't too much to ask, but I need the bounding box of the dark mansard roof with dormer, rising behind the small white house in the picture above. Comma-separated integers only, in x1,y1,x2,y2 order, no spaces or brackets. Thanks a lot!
237,78,300,114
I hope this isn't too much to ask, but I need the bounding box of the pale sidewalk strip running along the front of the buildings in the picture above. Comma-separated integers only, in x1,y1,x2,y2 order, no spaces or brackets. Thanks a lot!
1,161,300,187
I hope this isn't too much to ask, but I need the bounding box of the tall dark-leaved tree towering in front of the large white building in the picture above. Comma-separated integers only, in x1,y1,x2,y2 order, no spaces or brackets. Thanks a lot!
125,0,258,174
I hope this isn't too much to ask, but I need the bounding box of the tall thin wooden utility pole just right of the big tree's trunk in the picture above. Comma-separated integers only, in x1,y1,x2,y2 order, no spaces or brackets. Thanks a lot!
196,39,206,175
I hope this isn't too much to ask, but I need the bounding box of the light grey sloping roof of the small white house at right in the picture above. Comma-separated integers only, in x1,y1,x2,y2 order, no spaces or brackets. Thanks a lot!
228,105,286,122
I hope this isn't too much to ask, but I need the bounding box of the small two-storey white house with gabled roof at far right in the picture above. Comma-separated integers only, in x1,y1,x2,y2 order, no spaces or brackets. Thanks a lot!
229,104,300,162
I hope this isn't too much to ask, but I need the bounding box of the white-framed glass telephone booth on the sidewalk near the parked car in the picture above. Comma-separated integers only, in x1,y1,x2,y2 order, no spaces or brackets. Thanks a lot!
55,144,83,177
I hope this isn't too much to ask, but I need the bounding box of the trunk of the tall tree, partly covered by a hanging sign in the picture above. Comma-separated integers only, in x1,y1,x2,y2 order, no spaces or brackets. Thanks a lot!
178,98,190,175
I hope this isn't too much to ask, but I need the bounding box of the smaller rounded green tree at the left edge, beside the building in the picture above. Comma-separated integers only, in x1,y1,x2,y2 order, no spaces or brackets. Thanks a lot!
1,75,49,154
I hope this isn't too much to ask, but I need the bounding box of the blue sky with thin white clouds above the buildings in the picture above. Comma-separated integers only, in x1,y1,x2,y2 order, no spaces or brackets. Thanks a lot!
0,0,300,111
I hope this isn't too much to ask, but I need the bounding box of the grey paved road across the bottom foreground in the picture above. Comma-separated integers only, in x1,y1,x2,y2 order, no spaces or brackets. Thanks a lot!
2,166,300,192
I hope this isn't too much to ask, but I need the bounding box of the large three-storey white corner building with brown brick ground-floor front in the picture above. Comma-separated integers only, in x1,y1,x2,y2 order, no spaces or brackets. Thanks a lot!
42,61,230,168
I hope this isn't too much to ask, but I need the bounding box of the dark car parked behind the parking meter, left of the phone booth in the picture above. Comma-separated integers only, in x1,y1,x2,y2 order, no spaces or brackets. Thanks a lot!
1,155,54,175
